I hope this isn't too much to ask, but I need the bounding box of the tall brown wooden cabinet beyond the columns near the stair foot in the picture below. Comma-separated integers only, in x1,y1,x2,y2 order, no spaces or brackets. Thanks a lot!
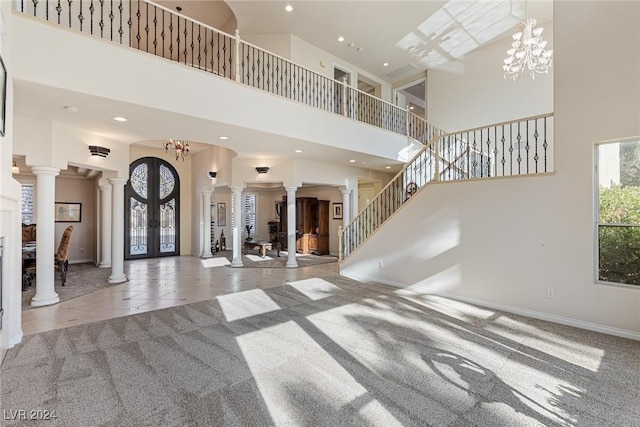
276,197,329,255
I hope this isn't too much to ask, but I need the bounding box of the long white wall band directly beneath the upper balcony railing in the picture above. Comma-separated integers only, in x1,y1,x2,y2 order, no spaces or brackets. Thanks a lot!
13,14,407,164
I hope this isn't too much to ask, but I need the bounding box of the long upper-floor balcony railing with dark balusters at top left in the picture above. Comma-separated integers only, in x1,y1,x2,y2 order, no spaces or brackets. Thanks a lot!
17,0,434,143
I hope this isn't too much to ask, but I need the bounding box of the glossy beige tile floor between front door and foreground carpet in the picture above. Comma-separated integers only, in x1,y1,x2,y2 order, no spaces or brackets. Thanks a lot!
22,256,338,335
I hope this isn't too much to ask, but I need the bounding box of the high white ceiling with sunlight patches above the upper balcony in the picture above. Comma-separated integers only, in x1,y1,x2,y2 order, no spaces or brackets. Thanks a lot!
228,0,553,82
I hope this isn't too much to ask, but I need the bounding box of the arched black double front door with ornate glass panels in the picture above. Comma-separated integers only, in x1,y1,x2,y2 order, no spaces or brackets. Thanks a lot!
125,157,180,259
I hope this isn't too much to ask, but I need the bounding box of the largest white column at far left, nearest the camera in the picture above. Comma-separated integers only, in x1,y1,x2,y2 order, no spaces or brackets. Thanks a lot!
31,166,60,307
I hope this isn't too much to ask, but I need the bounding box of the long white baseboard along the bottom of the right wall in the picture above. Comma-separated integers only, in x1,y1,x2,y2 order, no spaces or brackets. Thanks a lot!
340,272,640,341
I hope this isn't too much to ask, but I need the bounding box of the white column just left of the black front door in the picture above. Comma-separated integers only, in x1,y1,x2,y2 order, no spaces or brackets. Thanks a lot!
107,178,127,283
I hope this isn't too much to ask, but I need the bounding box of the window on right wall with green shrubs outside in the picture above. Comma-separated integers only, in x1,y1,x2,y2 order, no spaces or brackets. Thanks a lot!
596,141,640,285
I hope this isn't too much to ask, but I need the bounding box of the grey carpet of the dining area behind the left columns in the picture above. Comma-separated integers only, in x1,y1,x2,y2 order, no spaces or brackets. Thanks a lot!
22,262,111,310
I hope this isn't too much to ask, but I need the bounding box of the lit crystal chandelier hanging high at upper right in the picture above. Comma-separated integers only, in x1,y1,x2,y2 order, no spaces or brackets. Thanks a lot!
502,14,553,81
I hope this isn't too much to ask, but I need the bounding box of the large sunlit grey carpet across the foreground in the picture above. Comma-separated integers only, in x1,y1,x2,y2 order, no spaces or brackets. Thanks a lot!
0,269,640,427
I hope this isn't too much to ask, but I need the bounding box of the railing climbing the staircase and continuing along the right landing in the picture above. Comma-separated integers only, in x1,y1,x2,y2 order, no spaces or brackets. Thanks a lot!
339,114,553,259
